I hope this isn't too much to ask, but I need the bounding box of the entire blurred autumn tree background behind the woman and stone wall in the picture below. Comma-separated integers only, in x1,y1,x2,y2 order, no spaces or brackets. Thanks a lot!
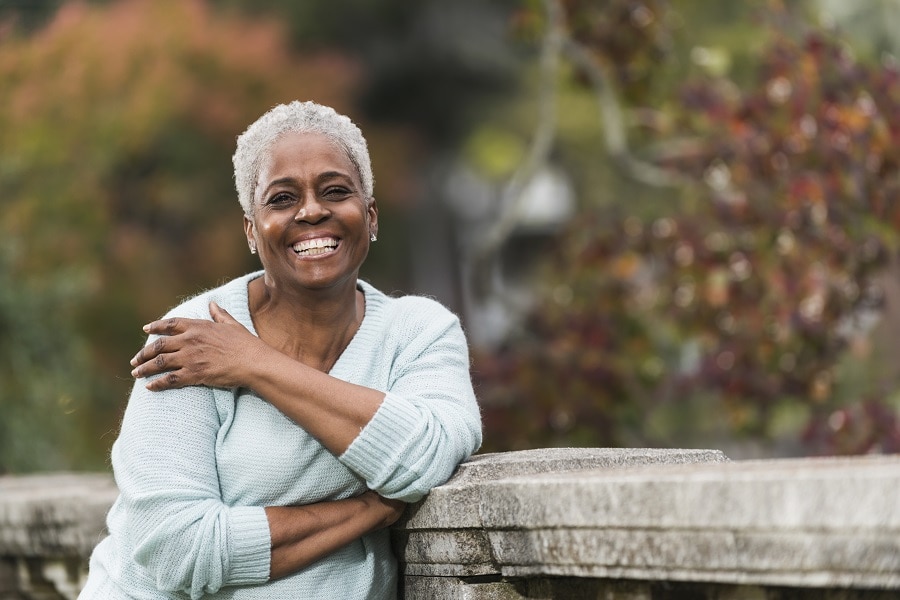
0,0,900,473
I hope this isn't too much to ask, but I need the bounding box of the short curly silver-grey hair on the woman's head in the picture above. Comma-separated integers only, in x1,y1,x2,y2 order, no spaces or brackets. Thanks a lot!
232,100,375,216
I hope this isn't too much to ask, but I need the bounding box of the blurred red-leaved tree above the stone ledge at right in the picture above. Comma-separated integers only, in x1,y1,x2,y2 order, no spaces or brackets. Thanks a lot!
477,0,900,452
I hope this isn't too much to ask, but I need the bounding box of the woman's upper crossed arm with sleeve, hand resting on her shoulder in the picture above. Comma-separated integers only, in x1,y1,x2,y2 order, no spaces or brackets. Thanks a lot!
132,304,481,502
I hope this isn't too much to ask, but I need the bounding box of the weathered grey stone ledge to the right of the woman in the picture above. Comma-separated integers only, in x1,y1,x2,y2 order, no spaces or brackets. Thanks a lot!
396,456,900,590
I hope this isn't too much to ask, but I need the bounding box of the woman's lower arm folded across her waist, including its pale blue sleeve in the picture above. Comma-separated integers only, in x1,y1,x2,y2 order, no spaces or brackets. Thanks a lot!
111,324,405,598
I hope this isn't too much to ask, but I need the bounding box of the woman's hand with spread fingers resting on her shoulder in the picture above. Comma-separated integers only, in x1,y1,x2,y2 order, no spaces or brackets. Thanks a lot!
131,302,265,392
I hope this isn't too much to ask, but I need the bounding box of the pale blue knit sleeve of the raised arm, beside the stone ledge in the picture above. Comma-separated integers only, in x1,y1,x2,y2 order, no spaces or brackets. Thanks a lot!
340,307,481,502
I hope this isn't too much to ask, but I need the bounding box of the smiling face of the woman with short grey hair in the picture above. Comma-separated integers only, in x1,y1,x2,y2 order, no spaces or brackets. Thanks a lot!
244,133,378,289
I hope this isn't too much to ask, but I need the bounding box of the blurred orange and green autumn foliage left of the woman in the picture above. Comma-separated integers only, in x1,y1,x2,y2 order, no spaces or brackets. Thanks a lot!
0,0,378,471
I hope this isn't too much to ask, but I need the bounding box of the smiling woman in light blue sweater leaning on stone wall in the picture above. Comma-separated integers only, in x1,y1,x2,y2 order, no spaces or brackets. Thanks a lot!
81,102,481,600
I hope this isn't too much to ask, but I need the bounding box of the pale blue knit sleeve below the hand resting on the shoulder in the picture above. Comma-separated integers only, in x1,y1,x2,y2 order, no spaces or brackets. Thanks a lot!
112,316,271,598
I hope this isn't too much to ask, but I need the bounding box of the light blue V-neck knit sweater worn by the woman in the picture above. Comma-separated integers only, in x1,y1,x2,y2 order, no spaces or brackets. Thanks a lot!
80,273,481,600
